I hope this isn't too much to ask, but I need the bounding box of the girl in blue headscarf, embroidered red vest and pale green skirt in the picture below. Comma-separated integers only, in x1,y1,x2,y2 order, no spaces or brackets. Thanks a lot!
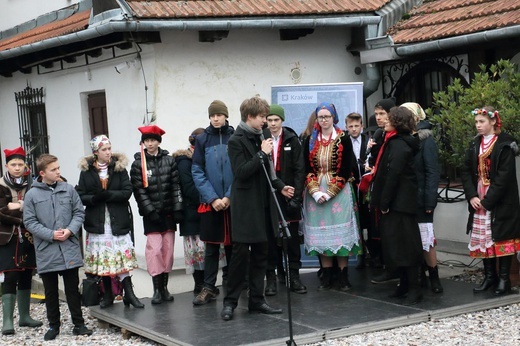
303,103,362,291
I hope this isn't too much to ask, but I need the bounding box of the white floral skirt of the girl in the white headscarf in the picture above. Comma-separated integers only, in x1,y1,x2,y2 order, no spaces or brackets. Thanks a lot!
85,233,137,276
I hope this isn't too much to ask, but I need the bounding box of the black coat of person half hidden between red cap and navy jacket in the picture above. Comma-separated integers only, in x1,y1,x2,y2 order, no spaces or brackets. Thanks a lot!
172,149,200,237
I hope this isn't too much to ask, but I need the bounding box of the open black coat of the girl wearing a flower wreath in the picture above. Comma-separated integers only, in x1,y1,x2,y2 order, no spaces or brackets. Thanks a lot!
461,133,520,241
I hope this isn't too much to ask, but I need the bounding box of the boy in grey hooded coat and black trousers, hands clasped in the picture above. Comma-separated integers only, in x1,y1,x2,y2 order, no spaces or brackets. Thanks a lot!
23,154,92,341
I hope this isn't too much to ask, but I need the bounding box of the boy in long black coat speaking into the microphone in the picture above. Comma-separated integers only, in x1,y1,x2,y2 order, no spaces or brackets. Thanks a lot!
220,97,294,321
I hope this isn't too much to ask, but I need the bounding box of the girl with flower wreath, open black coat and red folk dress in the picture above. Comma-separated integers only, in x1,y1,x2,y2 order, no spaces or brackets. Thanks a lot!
461,106,520,295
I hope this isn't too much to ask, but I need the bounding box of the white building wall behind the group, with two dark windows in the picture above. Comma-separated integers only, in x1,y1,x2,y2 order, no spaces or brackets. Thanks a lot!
0,28,364,267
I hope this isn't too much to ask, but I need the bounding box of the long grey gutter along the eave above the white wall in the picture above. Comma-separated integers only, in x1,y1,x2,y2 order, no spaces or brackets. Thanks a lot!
0,16,381,61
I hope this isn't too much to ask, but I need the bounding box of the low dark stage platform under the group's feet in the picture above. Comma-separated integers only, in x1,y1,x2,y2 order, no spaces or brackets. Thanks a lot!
90,268,520,346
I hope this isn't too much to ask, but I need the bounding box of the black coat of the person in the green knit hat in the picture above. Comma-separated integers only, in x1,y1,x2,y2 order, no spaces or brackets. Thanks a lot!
268,127,305,221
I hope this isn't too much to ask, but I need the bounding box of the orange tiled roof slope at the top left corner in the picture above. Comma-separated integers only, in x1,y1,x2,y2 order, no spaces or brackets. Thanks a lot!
0,11,90,51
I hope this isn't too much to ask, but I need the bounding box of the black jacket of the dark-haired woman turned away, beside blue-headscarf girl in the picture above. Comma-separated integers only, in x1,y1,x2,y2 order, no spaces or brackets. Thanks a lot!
370,134,419,214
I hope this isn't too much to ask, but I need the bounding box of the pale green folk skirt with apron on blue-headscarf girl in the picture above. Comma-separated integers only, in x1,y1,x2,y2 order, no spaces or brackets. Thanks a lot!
304,179,363,256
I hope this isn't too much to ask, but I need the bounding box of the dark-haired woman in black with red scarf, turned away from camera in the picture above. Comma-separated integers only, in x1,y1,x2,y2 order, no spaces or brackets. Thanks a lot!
370,107,423,305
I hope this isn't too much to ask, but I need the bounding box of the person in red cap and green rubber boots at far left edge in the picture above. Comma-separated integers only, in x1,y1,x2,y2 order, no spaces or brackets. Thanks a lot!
0,147,43,335
